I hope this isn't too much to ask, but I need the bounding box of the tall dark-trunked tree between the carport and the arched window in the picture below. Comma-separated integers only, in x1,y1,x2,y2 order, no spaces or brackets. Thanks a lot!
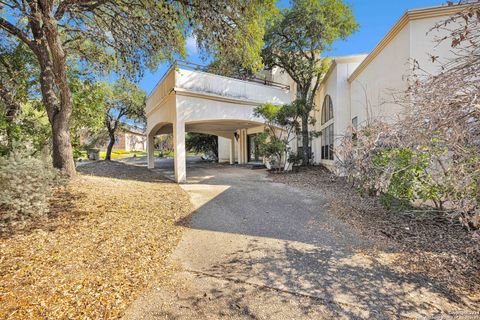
263,0,358,164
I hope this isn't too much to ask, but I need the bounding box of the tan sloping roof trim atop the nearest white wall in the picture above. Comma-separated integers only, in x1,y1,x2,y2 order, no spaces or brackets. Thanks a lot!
348,4,469,83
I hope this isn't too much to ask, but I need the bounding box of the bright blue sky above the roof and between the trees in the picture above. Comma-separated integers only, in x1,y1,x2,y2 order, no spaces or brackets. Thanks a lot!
140,0,446,94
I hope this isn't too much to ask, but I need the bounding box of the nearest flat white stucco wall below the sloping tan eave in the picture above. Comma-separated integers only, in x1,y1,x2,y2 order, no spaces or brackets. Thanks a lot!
350,16,453,129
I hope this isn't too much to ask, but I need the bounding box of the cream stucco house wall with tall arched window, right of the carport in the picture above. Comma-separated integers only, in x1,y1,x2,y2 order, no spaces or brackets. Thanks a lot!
312,6,459,169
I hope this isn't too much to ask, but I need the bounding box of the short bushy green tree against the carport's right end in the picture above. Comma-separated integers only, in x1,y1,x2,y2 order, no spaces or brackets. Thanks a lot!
255,100,300,171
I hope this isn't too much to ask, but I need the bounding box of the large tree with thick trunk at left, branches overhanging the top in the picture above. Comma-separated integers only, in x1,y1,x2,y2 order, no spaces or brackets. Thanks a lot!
0,0,273,176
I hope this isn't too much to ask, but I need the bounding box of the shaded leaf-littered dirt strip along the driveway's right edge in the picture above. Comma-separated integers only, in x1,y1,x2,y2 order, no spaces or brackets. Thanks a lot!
270,167,480,303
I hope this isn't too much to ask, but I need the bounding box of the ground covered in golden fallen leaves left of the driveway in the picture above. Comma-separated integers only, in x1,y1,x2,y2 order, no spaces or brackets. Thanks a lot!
0,161,190,319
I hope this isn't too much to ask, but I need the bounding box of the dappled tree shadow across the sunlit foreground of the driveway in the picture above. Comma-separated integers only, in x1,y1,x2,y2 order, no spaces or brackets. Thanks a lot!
205,241,471,319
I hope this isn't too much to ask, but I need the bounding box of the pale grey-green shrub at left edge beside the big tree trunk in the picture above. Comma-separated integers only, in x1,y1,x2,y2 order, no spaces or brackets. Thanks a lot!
0,151,66,223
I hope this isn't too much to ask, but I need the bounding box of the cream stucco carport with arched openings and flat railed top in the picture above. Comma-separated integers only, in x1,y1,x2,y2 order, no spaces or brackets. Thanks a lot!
146,61,291,183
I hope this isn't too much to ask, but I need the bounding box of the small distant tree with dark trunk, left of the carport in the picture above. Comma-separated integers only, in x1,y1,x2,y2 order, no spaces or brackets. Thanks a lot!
105,79,146,161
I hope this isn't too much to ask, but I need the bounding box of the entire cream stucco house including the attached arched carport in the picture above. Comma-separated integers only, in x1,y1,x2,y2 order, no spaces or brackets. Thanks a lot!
146,6,468,182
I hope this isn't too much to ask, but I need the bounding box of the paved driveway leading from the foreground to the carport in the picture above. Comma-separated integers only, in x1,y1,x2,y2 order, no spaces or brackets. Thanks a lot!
126,158,464,319
